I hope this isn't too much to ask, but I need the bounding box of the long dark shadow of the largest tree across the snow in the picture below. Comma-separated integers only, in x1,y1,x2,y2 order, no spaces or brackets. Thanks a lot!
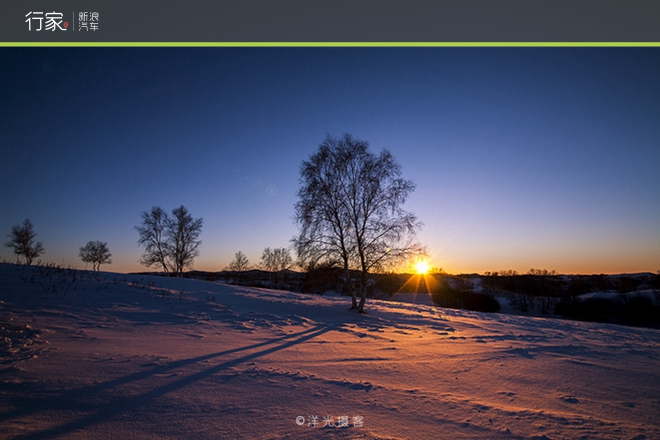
0,325,336,439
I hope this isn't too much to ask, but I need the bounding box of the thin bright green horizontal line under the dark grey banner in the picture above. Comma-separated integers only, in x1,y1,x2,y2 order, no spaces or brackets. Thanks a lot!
0,41,660,47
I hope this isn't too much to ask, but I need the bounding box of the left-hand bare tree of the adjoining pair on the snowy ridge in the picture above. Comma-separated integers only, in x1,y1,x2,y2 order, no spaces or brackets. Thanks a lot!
135,206,169,275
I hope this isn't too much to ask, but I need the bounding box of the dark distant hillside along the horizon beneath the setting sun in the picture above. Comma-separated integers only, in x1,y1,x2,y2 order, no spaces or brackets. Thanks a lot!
134,268,660,328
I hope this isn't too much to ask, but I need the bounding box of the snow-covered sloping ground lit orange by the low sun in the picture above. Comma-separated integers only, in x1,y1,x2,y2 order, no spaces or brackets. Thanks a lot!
0,265,660,439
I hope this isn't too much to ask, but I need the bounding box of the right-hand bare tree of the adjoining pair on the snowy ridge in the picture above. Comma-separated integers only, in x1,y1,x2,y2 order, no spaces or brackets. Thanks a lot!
165,205,203,276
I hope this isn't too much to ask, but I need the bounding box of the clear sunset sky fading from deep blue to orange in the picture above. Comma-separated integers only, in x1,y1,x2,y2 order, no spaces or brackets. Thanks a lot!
0,47,660,273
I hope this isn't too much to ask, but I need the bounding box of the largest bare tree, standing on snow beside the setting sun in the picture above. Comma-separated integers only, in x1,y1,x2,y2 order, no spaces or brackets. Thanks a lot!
293,134,425,312
